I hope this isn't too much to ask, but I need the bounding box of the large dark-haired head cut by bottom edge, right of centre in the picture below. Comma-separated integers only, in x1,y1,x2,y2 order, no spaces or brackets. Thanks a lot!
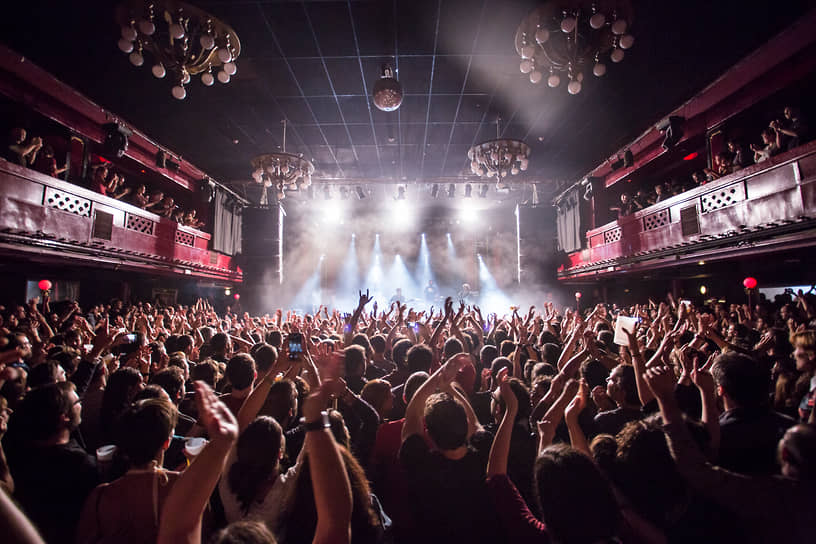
534,444,621,544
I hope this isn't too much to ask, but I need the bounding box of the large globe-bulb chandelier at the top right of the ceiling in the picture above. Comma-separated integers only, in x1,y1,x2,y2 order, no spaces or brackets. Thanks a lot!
516,0,635,94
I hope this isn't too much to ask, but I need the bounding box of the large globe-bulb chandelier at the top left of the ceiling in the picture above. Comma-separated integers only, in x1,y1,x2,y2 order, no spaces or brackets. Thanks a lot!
116,0,241,100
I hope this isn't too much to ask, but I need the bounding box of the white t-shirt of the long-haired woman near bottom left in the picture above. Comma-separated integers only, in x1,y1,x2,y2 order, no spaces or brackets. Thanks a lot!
218,449,300,532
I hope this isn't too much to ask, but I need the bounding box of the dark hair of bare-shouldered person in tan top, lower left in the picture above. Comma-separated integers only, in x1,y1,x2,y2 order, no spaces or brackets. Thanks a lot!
116,399,178,466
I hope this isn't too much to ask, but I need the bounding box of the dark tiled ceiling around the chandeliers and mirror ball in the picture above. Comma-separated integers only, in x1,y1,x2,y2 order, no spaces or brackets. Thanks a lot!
0,0,810,196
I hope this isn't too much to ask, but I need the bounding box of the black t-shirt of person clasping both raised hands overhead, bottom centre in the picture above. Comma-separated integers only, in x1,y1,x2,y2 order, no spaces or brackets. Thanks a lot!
399,431,498,544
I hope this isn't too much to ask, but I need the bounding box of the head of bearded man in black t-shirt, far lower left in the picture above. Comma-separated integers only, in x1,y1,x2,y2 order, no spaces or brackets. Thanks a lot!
12,382,82,441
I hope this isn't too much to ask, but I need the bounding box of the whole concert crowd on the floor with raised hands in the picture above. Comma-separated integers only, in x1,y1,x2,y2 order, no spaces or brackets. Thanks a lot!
0,286,816,544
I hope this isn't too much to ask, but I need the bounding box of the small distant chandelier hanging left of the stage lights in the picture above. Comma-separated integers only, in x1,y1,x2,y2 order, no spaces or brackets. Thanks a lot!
252,119,314,205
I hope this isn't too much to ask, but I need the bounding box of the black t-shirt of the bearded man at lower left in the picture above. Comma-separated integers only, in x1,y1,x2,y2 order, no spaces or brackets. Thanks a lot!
9,440,100,544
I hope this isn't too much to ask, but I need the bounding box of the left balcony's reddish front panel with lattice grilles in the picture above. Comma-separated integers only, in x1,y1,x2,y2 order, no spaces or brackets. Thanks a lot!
0,159,241,281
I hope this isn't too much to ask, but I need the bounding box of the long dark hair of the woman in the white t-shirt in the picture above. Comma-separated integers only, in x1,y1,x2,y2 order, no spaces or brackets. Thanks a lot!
227,416,283,514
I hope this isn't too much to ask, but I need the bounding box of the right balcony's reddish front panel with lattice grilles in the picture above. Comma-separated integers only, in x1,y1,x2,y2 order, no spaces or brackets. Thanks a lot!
558,142,816,279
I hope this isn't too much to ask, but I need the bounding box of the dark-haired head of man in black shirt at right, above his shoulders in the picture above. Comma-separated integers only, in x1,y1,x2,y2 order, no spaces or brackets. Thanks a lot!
711,352,771,409
